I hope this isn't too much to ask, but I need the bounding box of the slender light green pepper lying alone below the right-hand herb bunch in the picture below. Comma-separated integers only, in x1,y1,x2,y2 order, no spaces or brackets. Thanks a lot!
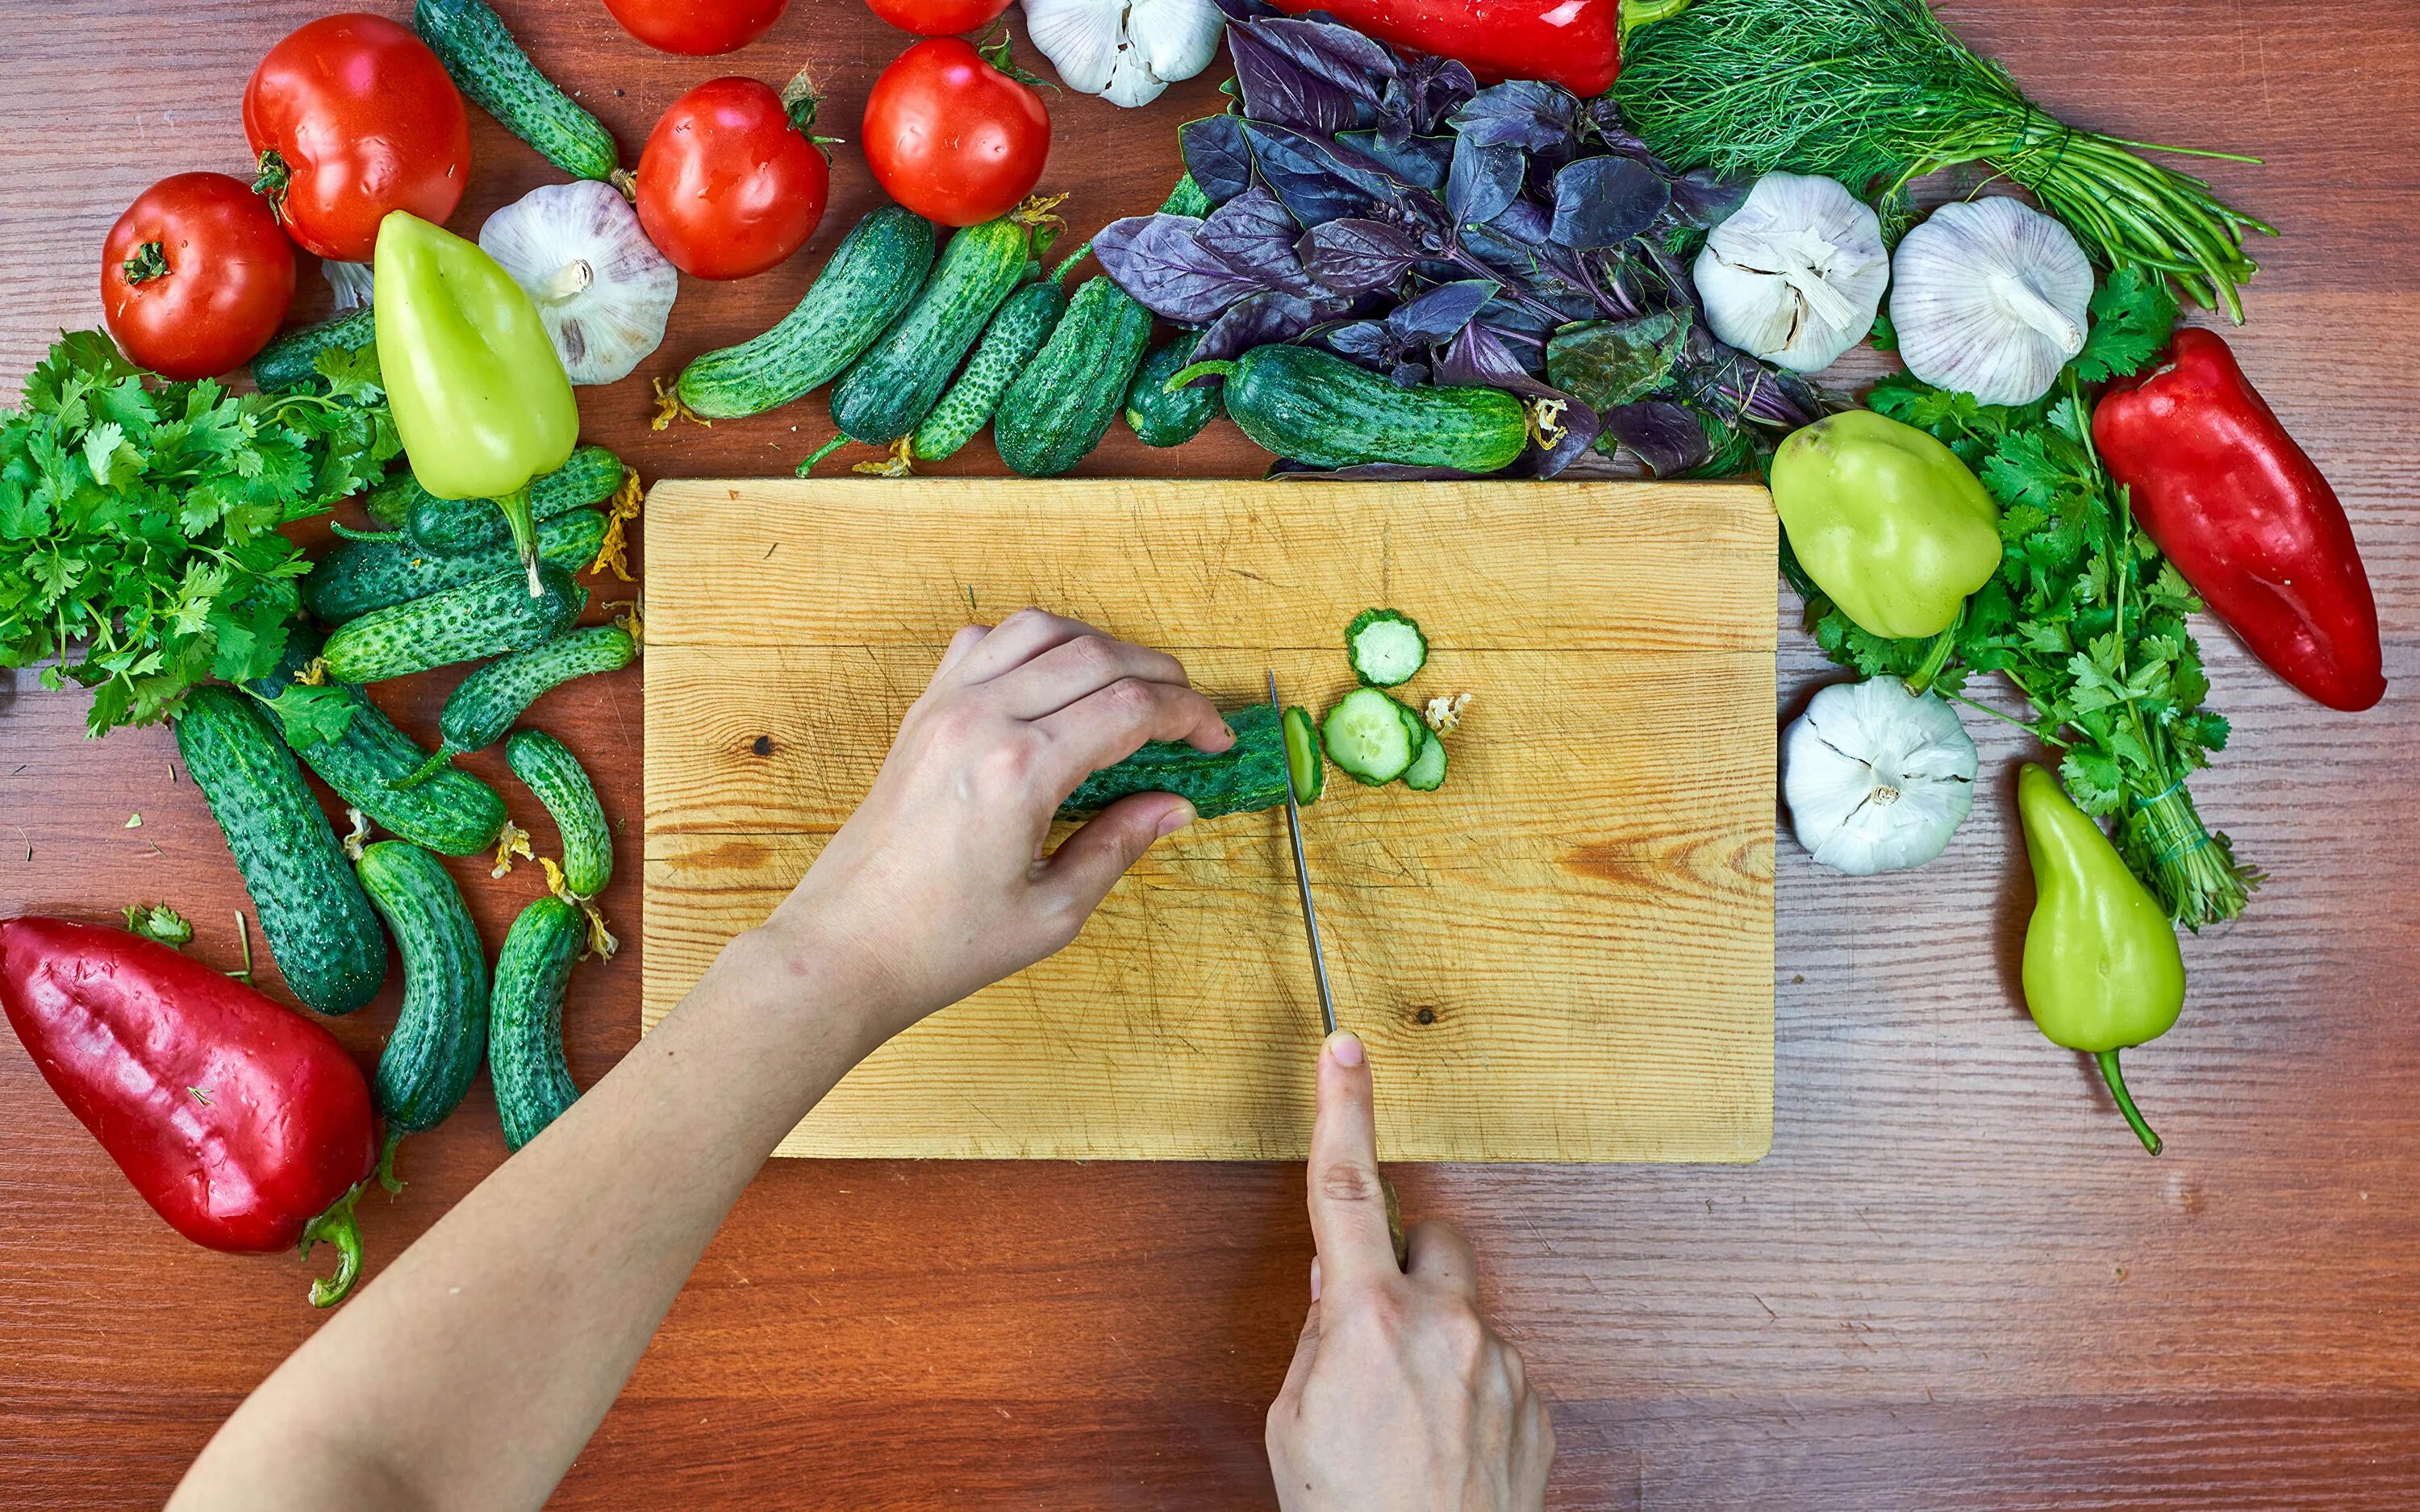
2016,762,2185,1154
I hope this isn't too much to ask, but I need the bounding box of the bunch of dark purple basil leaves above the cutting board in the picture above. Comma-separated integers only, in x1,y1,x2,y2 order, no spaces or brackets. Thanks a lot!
1094,0,1825,477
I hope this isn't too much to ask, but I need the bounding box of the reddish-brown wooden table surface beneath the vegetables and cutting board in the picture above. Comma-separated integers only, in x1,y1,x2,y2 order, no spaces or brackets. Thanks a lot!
0,0,2420,1512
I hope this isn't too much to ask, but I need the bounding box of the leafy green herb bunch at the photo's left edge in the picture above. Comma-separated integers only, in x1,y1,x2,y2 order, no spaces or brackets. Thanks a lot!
0,331,402,735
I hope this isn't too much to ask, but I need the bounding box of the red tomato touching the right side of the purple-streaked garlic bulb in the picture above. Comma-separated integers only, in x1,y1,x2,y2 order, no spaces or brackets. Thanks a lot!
639,77,832,278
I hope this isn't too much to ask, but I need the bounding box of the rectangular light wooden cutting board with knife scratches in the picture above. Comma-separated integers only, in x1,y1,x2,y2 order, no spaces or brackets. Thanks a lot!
644,479,1774,1161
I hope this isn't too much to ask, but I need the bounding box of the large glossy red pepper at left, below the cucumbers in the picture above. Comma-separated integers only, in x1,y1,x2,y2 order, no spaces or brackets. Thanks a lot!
0,919,378,1306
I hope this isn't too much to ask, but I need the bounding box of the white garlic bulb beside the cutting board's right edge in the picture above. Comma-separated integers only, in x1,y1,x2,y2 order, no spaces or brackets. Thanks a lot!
1781,677,1975,876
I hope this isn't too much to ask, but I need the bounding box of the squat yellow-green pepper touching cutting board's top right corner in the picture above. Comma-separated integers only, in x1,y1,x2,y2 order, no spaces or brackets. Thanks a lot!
1771,409,2001,641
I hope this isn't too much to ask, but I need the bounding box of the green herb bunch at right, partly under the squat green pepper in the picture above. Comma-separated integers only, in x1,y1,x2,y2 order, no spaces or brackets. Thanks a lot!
1784,269,2260,929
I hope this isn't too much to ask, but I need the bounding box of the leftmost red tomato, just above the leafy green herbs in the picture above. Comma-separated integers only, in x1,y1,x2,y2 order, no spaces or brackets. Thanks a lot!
102,174,295,377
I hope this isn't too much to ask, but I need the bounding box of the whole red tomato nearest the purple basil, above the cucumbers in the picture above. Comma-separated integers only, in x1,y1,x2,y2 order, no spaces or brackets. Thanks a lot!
866,36,1050,225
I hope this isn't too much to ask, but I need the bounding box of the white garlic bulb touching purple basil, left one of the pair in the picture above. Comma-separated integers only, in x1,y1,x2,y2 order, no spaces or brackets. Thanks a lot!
1692,174,1890,373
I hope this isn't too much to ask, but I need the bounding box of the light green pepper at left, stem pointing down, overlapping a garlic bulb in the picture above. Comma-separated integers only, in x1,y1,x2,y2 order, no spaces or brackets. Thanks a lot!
373,210,581,598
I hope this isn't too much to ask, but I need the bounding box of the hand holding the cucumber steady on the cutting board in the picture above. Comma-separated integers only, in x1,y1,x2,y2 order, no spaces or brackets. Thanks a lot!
767,610,1234,1038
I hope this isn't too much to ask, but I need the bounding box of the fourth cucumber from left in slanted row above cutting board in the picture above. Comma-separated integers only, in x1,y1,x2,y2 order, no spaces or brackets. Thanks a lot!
992,276,1152,477
